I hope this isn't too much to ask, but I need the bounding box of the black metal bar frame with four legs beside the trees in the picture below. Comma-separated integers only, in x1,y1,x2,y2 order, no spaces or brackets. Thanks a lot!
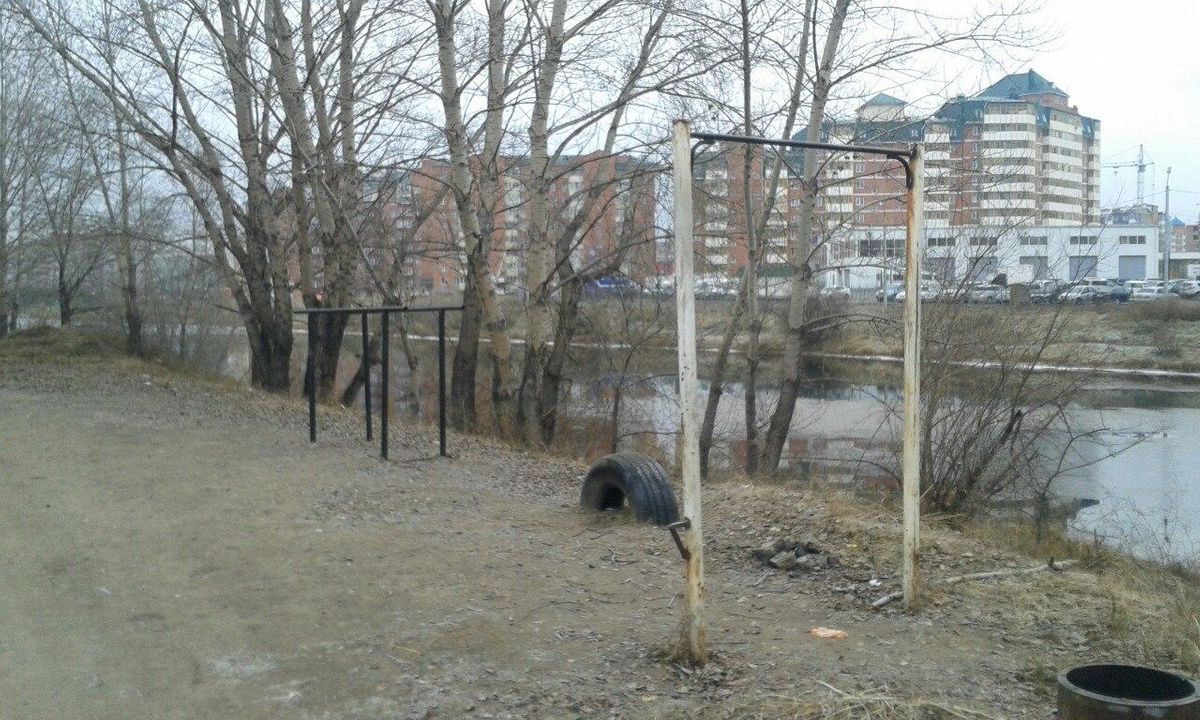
295,305,463,460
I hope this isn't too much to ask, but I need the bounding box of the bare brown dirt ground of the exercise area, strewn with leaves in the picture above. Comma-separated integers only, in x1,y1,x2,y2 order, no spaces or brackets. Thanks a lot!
0,333,1185,720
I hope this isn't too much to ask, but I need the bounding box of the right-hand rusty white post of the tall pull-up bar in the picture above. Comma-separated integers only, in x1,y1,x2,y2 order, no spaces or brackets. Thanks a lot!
902,144,925,610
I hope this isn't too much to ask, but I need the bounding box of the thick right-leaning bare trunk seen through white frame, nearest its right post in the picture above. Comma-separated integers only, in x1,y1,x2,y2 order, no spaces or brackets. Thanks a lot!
760,0,850,472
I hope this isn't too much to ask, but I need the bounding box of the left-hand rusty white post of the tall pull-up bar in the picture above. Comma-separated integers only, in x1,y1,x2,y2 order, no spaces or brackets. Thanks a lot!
672,120,708,665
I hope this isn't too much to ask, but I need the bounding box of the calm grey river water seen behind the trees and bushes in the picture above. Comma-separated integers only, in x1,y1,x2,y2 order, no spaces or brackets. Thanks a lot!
224,337,1200,564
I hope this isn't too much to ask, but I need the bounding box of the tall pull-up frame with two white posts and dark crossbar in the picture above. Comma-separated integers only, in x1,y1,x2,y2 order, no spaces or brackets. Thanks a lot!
672,120,924,664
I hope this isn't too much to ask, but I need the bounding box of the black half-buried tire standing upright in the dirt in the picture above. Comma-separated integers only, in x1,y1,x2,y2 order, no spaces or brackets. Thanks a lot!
580,452,679,524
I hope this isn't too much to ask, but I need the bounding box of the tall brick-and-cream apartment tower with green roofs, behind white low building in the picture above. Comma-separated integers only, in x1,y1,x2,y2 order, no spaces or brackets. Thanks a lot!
797,70,1100,229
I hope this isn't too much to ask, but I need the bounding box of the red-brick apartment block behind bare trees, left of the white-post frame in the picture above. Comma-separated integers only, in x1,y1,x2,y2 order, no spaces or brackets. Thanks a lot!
355,154,658,294
